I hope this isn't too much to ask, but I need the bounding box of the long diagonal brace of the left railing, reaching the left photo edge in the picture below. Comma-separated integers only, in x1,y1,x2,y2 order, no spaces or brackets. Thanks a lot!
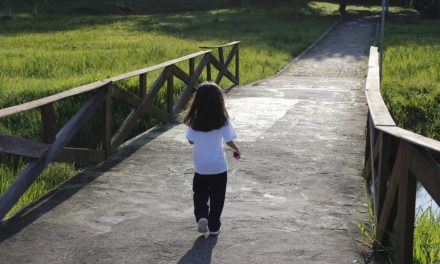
0,91,105,219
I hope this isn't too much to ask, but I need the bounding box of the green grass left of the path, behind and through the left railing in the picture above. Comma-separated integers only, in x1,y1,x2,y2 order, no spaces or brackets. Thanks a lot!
0,2,338,219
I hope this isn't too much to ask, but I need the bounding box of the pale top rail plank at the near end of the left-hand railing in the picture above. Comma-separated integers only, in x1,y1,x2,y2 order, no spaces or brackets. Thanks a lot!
0,81,110,118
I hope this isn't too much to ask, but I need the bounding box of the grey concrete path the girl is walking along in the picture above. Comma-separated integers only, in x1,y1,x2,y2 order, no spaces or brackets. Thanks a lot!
0,19,374,264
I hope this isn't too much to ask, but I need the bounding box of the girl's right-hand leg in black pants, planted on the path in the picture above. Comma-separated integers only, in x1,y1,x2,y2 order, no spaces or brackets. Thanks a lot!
208,172,227,231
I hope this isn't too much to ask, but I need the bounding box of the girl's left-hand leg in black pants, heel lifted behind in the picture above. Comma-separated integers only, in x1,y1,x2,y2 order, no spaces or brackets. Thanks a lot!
193,173,209,222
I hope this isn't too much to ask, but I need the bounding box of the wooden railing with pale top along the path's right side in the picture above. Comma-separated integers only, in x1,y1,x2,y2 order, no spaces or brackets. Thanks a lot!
365,47,440,263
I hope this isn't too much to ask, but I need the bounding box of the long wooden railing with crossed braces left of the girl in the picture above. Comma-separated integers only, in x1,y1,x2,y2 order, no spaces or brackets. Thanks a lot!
0,41,240,221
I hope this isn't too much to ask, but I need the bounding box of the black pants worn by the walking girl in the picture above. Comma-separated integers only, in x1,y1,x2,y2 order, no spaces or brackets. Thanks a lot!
193,171,227,231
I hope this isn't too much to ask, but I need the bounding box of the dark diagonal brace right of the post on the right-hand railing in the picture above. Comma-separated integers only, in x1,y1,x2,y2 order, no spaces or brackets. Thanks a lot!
409,148,440,205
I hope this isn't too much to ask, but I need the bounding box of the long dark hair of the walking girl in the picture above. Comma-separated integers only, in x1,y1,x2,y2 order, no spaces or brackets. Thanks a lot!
183,82,229,132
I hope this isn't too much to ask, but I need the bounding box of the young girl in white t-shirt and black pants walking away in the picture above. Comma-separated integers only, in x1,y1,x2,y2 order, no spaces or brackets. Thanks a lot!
184,82,241,235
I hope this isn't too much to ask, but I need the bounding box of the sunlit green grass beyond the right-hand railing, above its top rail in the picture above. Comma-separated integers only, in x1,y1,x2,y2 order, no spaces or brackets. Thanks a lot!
381,18,440,140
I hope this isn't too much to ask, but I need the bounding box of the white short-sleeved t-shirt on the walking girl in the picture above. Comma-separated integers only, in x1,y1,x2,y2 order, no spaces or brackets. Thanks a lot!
186,120,237,175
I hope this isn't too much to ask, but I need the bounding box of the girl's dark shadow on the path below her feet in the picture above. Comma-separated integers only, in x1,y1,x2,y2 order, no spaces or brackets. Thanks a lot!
177,235,218,264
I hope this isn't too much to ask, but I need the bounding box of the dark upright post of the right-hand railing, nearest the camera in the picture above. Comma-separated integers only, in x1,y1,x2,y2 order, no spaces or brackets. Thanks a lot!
396,142,416,264
